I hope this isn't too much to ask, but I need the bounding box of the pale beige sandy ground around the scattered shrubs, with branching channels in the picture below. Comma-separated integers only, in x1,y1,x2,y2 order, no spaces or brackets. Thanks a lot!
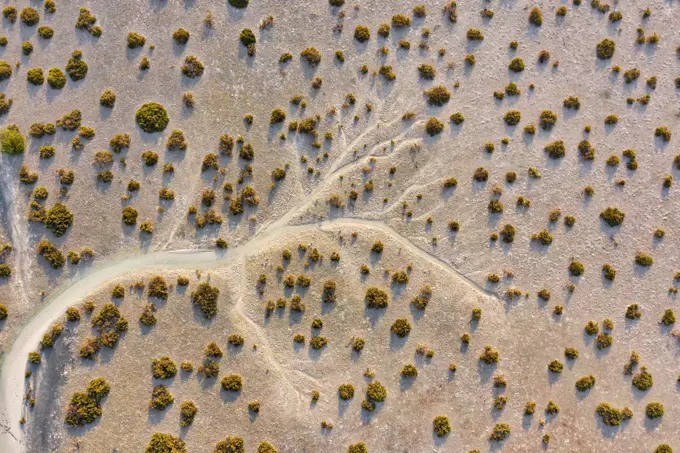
0,0,680,452
